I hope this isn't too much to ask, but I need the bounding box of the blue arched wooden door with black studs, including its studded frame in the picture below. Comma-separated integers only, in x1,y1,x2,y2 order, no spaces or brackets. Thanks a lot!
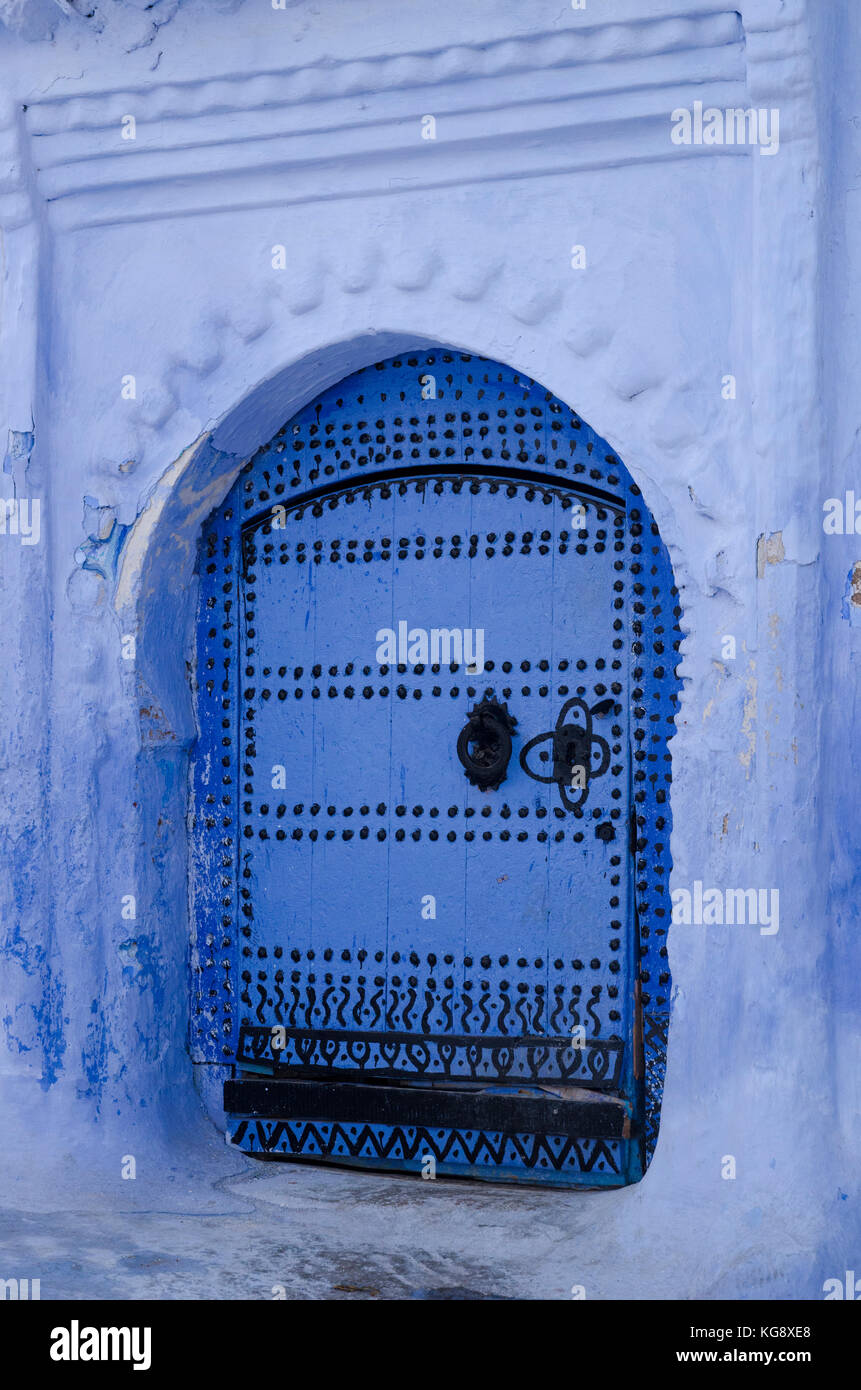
192,349,679,1187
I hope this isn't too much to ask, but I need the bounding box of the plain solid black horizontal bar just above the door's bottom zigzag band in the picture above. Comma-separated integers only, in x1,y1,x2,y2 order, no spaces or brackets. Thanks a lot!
224,1080,629,1138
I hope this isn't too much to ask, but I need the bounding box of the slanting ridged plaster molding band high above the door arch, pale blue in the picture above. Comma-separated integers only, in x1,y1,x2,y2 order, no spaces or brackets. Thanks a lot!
26,10,750,228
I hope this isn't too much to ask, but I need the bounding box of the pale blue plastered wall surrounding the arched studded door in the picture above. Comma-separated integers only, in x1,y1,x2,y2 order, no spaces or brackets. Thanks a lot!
0,0,861,1297
